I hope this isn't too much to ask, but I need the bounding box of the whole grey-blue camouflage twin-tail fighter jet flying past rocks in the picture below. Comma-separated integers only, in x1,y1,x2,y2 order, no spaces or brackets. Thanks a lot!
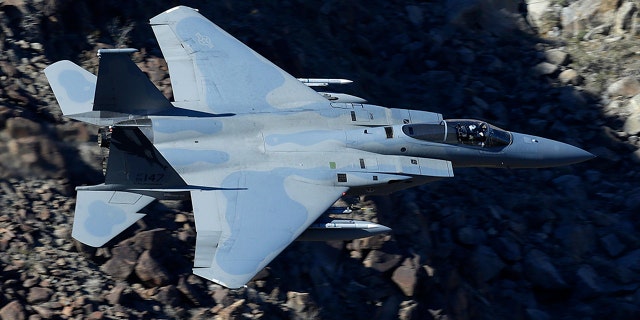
45,6,593,288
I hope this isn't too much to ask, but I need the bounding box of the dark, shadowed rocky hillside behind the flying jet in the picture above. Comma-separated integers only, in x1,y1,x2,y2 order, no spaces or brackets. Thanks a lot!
0,0,640,320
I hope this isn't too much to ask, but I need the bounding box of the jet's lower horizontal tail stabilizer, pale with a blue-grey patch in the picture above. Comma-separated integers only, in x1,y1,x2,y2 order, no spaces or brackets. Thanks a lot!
71,189,155,247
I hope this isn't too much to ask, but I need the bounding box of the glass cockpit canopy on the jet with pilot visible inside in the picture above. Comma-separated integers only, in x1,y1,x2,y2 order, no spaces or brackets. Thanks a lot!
402,119,512,148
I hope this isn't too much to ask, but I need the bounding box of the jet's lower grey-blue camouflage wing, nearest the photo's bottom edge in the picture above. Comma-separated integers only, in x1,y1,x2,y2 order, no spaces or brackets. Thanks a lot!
191,172,347,288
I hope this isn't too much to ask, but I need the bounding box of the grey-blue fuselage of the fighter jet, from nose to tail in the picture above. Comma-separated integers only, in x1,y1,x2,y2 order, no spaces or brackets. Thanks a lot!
136,103,592,194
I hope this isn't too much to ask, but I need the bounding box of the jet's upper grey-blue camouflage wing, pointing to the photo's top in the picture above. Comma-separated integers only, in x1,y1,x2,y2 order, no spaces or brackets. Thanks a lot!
150,6,327,113
